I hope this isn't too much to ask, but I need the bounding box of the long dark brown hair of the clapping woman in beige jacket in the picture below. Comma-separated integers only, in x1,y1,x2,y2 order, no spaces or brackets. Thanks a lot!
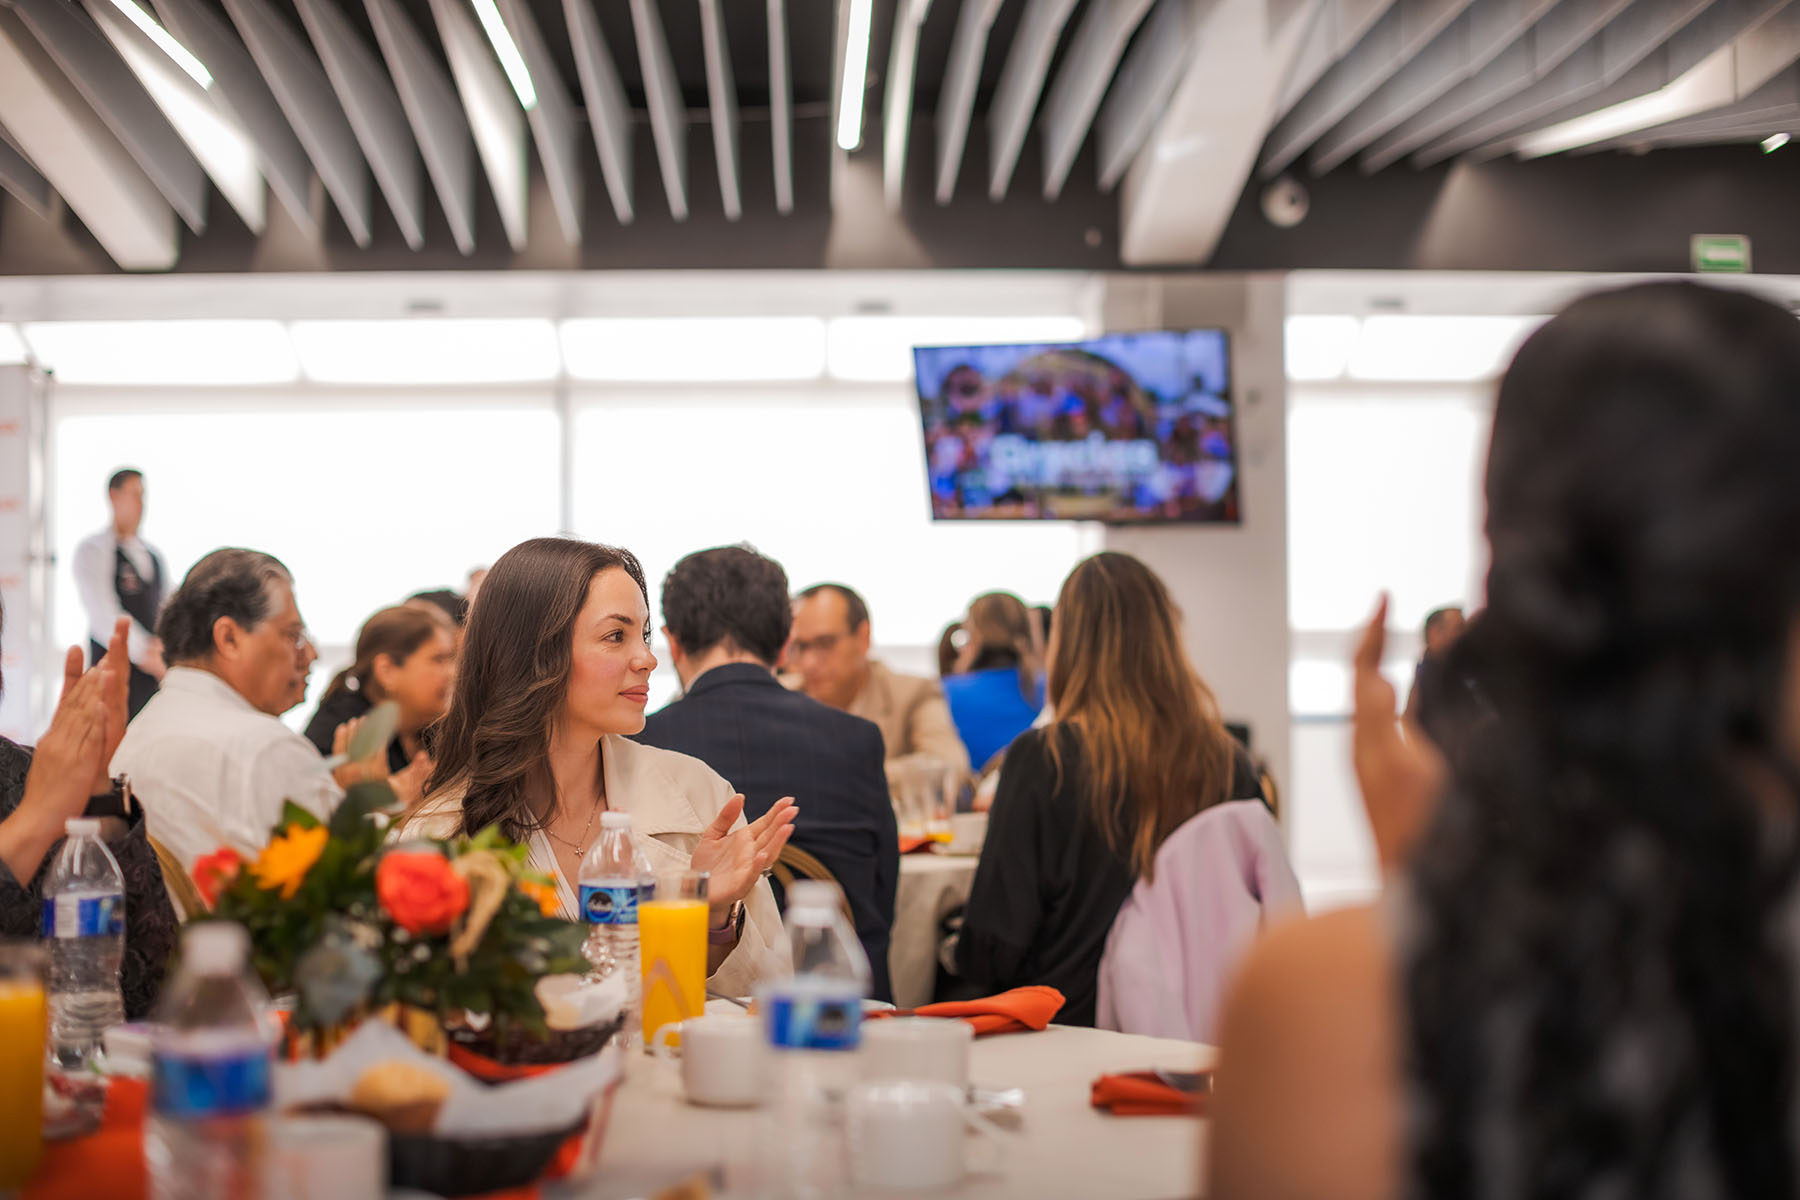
425,538,650,840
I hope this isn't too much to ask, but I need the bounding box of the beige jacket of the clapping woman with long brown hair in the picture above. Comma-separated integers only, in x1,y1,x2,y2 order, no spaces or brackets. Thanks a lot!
396,734,792,997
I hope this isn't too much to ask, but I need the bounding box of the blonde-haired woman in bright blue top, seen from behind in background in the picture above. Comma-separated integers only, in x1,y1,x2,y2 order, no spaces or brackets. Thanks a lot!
943,592,1044,774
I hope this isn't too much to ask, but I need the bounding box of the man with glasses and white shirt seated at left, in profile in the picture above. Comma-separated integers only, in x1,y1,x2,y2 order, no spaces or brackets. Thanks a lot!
112,549,344,869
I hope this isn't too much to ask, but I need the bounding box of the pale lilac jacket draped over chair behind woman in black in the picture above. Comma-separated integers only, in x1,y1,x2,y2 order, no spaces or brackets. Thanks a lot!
1094,799,1303,1042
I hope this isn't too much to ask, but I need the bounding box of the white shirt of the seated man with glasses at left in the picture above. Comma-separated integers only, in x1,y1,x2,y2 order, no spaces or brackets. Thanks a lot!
112,667,344,869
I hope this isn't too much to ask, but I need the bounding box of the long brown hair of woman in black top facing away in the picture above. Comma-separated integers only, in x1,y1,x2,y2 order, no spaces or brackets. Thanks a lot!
1048,551,1233,880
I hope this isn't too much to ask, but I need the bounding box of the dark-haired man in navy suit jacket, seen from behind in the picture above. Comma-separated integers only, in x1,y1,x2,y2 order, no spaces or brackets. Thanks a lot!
635,545,900,1000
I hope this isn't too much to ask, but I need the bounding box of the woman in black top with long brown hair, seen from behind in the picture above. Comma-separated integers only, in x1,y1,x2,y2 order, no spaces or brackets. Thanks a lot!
956,551,1262,1025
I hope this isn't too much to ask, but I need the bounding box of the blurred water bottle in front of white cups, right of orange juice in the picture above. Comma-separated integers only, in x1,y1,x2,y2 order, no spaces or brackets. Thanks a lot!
756,882,869,1200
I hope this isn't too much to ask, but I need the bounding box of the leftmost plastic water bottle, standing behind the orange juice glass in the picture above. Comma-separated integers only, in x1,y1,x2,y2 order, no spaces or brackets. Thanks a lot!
43,817,124,1070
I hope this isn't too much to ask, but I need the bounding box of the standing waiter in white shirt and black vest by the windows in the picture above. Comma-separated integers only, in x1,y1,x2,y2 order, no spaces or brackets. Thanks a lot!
76,468,167,716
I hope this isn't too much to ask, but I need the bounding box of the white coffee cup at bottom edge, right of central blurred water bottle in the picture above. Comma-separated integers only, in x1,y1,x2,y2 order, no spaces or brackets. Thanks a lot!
844,1079,1006,1187
